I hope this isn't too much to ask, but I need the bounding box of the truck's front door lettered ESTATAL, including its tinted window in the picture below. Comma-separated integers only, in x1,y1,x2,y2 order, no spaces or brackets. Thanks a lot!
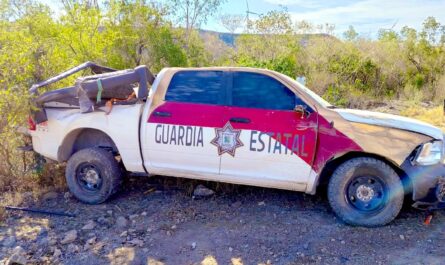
216,71,317,190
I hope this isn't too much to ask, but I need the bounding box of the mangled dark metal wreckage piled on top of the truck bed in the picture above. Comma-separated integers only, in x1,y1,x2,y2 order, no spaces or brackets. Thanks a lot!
29,62,155,123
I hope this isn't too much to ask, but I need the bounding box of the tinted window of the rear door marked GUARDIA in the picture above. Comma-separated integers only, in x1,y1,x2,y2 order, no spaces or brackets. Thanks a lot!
165,71,225,104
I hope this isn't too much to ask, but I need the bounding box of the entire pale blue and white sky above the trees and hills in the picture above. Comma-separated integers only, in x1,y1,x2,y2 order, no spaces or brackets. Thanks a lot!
40,0,445,38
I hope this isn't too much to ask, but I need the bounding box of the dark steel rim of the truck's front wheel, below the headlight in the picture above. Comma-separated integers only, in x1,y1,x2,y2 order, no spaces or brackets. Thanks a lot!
345,176,388,213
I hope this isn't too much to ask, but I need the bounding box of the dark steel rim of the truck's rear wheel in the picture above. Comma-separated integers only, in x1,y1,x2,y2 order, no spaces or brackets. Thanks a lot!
76,163,102,191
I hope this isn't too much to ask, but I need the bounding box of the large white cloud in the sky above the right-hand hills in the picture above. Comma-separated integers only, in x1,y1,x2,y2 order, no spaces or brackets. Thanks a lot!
288,0,445,35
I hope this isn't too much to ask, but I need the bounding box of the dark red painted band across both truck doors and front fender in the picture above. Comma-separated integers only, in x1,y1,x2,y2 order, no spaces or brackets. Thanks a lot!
147,102,362,172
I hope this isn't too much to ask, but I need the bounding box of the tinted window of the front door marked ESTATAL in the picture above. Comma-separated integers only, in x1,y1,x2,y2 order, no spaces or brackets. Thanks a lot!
232,72,300,110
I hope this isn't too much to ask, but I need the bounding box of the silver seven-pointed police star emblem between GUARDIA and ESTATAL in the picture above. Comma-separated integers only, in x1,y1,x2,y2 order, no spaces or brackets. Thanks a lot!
210,122,243,157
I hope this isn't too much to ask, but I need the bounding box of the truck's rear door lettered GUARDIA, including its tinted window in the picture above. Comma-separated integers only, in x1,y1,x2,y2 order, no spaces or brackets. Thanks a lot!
144,70,227,174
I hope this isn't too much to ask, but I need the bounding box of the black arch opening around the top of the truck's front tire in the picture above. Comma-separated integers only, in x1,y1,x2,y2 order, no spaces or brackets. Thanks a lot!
315,151,412,194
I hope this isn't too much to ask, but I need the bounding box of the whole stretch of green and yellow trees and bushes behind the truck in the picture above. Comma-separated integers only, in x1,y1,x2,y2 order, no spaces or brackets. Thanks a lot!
0,0,445,190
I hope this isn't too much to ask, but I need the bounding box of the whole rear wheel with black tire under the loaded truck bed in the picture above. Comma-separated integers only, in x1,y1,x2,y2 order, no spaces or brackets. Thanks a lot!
65,148,122,204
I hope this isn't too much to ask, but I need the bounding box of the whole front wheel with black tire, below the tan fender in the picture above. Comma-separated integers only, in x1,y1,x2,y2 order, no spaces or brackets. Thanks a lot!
328,157,404,227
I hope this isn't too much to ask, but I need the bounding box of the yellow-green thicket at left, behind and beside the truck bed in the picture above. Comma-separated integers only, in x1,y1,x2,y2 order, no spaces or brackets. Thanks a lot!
0,0,194,188
